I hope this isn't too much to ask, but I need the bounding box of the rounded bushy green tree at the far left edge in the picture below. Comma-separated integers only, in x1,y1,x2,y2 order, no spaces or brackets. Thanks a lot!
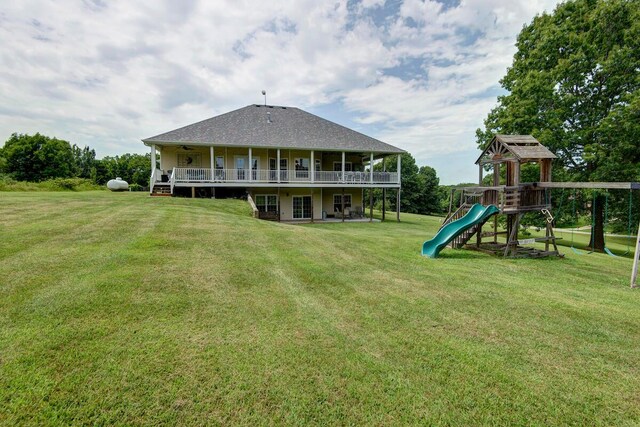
0,133,75,182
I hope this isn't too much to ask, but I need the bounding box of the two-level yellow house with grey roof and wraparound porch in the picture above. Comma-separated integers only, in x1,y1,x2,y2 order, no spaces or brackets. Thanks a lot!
142,105,404,221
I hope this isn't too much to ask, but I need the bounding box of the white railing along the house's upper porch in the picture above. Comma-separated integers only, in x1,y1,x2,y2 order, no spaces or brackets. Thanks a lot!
170,168,398,186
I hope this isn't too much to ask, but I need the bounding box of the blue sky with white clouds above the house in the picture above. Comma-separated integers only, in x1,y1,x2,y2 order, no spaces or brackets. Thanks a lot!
0,0,557,184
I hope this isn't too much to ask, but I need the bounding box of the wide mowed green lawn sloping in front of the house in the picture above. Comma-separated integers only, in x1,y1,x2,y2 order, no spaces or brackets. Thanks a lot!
0,192,640,426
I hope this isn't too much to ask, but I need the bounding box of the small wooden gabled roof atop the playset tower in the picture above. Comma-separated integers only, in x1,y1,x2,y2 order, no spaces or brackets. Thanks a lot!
476,135,557,164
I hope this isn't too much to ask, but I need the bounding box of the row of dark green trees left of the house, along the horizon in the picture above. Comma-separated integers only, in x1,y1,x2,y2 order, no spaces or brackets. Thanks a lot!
0,133,151,188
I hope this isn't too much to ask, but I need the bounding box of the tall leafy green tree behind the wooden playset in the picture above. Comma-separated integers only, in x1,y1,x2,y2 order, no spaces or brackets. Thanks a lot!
476,0,640,251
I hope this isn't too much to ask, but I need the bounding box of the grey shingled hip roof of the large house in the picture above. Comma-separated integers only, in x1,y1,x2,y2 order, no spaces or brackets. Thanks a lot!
142,104,405,153
